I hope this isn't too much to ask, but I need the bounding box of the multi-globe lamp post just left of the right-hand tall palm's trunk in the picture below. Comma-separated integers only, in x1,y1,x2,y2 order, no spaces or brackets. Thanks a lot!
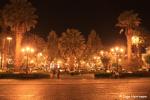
110,47,124,71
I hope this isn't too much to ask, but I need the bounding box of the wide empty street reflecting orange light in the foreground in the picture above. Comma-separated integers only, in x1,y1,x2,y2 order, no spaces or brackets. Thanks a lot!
0,78,150,100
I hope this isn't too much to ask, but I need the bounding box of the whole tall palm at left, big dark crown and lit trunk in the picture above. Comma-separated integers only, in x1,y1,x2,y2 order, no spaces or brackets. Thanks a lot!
2,0,37,69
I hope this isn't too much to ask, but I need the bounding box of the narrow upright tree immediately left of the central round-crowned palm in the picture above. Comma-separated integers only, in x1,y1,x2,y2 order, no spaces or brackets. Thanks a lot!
47,31,58,61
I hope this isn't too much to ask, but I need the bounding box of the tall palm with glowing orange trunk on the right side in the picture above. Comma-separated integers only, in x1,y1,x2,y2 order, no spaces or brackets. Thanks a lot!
117,10,141,62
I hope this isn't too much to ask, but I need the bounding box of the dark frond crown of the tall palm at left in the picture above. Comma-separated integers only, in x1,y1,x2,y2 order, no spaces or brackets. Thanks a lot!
2,0,38,31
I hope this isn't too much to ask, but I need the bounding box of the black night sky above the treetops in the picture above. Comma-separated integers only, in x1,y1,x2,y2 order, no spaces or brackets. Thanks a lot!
0,0,150,44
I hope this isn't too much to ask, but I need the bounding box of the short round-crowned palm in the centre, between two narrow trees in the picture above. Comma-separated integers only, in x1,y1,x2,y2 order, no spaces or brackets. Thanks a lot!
59,29,85,70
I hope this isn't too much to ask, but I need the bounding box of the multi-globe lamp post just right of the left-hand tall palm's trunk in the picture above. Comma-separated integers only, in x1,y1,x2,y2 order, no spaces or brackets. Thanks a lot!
22,47,34,74
